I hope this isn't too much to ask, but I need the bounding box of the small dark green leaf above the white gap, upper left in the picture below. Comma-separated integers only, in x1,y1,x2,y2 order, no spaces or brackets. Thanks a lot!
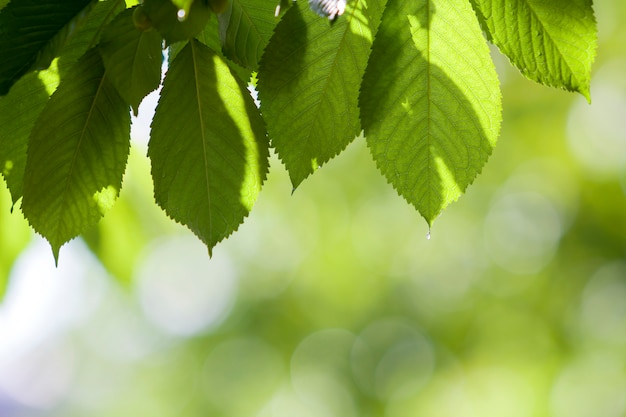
99,8,163,114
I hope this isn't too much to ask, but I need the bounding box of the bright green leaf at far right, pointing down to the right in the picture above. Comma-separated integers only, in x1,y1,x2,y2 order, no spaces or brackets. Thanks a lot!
470,0,597,100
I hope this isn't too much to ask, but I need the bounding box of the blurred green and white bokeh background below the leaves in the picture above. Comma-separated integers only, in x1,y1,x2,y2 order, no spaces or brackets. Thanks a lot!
0,0,626,417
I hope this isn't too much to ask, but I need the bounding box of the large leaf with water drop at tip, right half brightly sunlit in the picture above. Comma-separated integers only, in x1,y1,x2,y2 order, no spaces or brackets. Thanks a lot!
360,0,501,225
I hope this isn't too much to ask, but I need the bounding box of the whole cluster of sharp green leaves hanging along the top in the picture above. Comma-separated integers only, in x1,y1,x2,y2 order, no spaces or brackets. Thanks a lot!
0,0,597,258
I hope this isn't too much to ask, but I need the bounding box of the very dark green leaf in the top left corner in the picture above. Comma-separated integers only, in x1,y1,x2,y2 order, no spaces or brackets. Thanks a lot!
0,0,92,96
